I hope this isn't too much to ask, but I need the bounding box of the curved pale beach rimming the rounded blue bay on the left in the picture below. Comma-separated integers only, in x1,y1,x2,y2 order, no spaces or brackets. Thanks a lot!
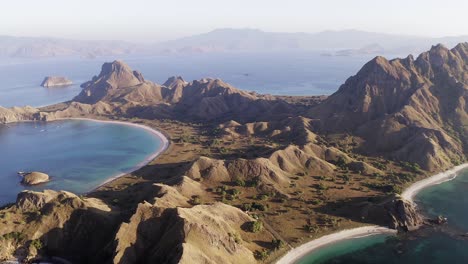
53,118,169,193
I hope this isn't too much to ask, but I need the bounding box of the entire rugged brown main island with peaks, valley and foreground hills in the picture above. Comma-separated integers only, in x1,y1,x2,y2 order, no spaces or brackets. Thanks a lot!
0,43,468,263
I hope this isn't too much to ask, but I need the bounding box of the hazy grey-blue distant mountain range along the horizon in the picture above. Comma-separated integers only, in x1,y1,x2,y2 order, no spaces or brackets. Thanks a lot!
0,29,468,58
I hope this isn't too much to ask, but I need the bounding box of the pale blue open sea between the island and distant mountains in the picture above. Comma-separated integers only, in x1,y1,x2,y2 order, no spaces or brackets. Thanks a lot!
0,52,373,107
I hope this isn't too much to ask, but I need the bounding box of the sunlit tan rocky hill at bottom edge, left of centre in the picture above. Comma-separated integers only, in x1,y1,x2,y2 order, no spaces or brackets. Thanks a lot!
114,183,268,263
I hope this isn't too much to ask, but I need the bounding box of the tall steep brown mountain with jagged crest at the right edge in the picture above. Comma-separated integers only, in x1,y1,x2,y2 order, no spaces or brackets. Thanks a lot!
309,43,468,170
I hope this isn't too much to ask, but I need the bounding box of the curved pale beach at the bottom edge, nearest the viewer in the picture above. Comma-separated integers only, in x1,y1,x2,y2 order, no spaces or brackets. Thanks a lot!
276,226,397,264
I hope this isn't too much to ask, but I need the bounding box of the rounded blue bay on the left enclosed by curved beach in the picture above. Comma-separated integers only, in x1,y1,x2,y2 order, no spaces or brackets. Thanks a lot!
0,120,161,205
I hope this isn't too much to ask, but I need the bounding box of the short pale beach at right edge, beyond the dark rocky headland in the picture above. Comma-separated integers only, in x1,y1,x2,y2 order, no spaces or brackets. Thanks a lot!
401,163,468,202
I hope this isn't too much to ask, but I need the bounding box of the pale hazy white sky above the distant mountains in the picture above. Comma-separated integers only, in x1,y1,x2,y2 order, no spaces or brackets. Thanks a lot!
0,0,468,41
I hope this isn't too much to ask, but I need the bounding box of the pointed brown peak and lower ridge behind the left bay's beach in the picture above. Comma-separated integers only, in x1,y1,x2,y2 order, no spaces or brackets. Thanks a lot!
68,61,295,120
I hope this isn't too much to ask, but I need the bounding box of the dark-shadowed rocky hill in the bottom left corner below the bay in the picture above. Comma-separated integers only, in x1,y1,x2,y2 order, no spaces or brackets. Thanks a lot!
0,190,117,263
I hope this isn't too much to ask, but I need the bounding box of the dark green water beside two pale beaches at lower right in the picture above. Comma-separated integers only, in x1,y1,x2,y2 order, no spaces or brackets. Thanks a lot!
298,170,468,264
